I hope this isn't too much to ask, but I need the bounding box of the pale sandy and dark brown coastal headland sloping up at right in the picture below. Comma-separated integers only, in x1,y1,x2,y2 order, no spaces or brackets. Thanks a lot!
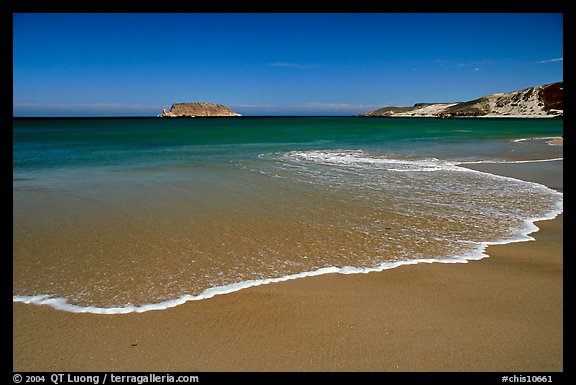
360,82,564,118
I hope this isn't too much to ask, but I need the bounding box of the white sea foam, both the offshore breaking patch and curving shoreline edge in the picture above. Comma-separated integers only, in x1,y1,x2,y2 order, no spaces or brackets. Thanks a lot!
13,150,563,314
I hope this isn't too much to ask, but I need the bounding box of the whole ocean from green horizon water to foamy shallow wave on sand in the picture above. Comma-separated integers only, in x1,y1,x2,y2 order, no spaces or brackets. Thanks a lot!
13,117,563,314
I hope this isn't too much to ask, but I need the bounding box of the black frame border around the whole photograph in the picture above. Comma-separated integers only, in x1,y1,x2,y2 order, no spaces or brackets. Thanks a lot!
5,0,576,385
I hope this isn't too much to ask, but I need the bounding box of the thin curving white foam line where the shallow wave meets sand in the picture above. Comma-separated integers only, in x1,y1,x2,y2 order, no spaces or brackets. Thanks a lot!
12,154,564,314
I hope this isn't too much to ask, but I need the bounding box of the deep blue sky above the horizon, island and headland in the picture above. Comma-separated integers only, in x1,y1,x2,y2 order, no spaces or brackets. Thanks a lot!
13,13,563,116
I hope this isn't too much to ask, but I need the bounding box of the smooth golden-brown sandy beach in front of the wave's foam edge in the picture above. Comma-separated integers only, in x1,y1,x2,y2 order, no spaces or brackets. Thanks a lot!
13,158,563,372
